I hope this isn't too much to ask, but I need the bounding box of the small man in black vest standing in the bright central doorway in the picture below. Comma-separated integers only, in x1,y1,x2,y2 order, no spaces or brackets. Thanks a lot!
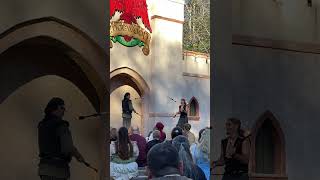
122,92,139,129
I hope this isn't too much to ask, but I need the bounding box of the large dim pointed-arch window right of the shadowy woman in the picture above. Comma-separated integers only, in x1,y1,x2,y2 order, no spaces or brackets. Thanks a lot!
250,111,287,179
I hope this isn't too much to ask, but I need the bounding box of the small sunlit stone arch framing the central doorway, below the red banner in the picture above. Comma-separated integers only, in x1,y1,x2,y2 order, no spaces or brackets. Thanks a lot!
110,67,150,133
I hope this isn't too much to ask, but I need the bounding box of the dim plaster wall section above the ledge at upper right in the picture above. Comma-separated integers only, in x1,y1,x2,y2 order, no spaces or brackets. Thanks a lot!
232,0,320,42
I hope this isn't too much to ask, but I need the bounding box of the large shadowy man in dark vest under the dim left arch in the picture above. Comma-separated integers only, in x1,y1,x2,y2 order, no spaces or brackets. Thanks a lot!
38,97,85,180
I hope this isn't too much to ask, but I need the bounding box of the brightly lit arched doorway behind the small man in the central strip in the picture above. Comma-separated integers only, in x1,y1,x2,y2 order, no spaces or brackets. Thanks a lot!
110,67,150,134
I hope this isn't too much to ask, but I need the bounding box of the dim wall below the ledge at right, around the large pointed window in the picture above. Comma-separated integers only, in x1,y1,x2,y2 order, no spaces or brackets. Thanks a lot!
232,46,320,180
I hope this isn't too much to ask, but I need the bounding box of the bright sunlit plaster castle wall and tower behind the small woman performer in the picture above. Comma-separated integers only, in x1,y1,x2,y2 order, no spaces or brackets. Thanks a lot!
149,0,210,138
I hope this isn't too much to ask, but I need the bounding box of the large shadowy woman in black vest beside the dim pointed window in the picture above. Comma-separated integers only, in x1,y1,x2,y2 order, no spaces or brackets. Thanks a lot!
213,118,250,180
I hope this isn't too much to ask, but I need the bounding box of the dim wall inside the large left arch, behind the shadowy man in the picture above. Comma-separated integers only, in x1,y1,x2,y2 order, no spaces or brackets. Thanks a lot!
0,76,104,180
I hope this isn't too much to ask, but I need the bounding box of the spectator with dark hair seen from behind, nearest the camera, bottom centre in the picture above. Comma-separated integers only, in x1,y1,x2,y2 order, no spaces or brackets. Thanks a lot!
147,142,191,180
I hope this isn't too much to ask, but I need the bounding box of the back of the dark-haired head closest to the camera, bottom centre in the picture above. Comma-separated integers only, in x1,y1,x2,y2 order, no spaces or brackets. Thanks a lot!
147,141,180,177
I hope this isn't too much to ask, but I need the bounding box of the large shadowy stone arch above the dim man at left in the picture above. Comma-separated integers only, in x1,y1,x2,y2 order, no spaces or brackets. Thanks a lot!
0,17,109,179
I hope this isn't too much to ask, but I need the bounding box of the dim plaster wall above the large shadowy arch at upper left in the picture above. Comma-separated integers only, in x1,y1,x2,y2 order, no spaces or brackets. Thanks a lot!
0,0,105,50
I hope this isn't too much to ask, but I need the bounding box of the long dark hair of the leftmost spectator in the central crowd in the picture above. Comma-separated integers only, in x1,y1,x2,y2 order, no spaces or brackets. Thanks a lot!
116,127,133,160
